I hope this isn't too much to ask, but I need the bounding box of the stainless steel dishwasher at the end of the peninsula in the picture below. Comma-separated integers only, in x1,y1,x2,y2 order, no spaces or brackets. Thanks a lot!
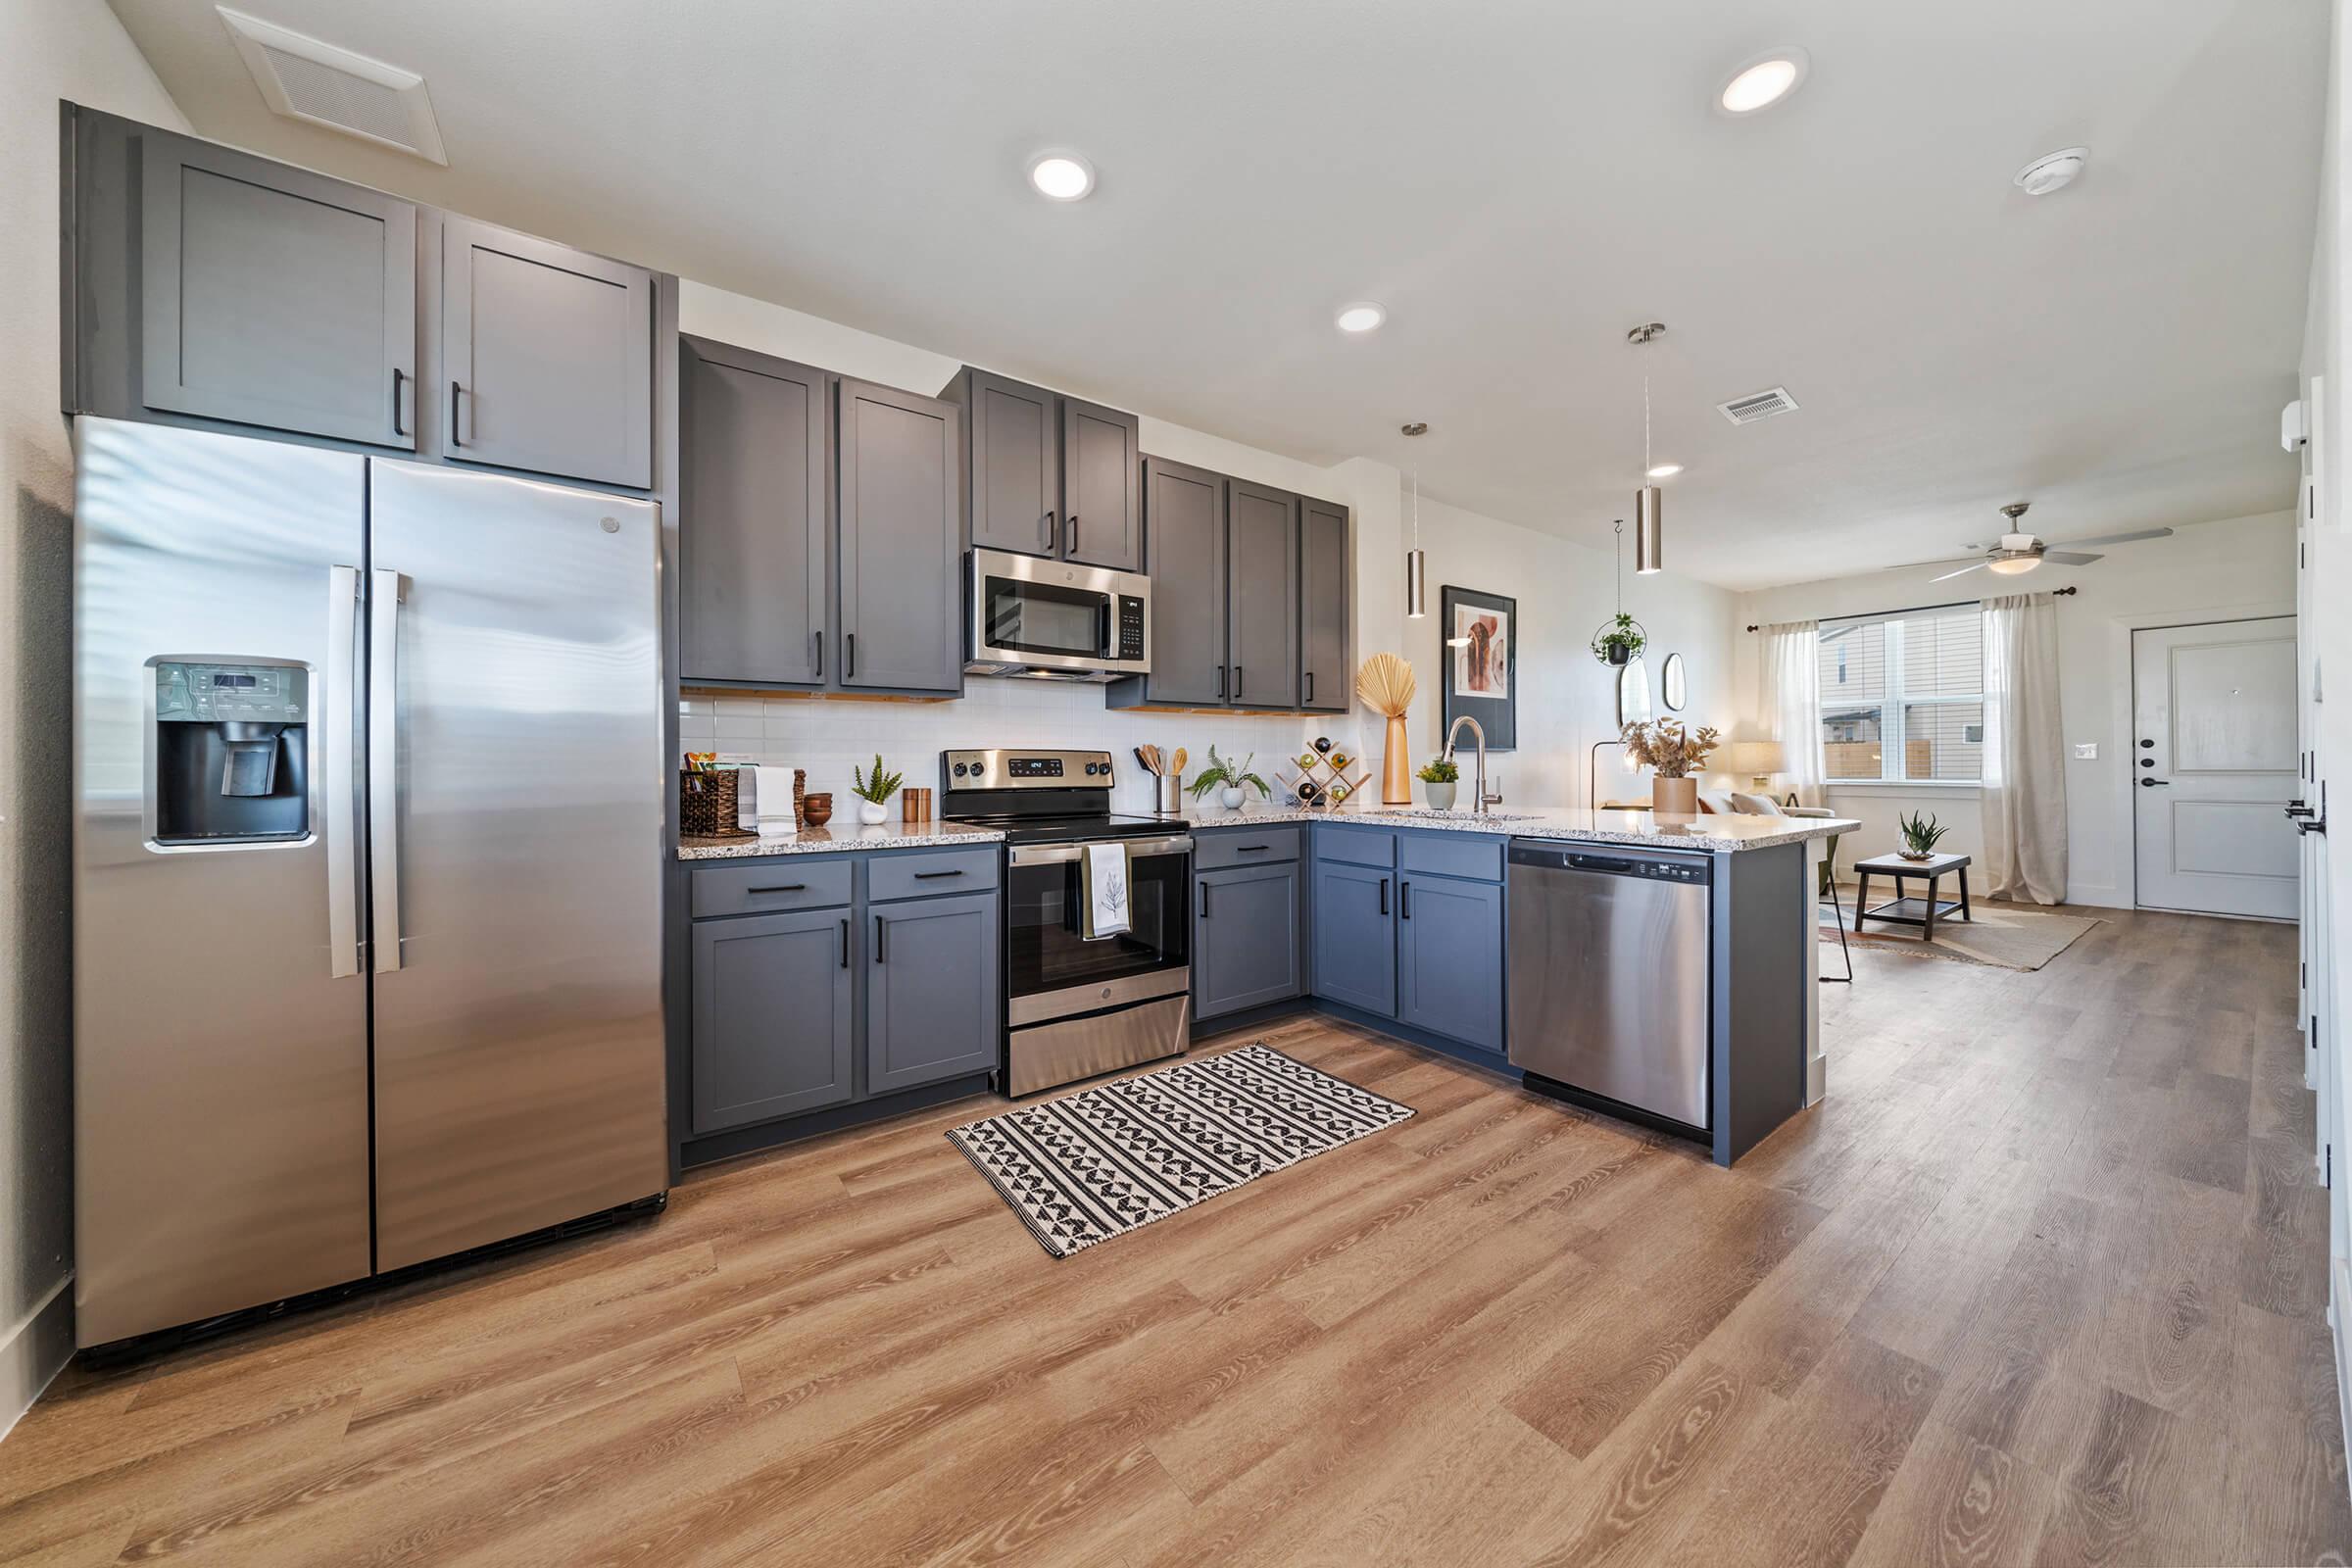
1507,839,1715,1133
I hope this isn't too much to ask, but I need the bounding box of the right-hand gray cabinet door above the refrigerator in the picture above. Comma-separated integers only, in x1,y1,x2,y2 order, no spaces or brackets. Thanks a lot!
435,217,654,489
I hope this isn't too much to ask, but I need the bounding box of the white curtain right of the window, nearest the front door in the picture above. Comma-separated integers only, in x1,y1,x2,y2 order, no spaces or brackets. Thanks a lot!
1983,592,2065,903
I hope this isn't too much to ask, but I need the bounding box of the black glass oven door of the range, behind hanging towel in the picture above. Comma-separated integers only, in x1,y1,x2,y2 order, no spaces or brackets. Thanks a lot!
1004,835,1193,1030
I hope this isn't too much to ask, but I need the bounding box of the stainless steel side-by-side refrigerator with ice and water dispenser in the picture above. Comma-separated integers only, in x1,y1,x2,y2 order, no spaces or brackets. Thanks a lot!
73,418,668,1345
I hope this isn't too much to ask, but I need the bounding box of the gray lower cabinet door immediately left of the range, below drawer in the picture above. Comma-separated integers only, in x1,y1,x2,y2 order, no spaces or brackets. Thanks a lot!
865,894,1002,1093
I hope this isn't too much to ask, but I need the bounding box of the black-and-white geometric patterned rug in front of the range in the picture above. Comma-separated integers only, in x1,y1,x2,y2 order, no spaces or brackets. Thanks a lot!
948,1044,1413,1257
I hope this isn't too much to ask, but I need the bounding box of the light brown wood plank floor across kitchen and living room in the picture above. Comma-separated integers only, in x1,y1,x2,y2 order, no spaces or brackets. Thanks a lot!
0,914,2352,1568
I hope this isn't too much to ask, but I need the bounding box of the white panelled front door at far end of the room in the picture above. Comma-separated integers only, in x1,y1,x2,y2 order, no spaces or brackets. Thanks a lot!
2131,615,2300,919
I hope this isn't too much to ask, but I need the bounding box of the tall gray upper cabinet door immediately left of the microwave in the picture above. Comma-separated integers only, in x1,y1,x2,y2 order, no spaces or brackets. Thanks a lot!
837,381,964,696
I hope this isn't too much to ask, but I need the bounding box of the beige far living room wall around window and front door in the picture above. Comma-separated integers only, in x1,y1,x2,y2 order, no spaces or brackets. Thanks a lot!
1739,512,2295,907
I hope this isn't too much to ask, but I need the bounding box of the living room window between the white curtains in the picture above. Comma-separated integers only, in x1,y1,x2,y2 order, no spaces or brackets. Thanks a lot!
1821,604,1985,783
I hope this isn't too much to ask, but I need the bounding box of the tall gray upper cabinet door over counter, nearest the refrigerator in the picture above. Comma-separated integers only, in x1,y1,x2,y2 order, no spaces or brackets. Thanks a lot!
680,336,833,686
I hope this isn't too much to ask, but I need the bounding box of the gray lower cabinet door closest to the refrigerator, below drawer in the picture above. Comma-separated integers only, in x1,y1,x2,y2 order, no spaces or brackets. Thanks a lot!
694,907,857,1136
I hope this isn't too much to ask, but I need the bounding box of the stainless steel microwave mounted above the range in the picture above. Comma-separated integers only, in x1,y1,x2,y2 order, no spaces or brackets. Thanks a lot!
964,550,1152,682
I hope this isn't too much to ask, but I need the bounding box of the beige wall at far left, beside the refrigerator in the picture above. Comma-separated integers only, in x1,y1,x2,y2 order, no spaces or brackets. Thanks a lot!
0,0,188,1429
